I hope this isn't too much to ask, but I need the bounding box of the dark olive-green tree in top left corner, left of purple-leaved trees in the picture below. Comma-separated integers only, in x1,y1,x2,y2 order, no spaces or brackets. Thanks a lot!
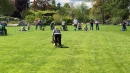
0,0,15,15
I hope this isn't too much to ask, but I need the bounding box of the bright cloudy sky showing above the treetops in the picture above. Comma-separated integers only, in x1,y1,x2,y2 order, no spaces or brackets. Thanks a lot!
30,0,92,8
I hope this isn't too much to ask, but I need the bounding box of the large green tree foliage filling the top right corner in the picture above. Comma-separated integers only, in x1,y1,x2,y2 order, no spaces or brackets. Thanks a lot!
90,0,129,22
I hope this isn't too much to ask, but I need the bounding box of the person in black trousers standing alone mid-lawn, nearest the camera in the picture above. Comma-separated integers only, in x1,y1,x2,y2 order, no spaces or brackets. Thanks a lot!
52,27,62,48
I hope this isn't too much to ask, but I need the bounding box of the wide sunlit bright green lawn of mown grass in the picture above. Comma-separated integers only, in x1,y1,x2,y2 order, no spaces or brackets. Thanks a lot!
0,25,130,73
